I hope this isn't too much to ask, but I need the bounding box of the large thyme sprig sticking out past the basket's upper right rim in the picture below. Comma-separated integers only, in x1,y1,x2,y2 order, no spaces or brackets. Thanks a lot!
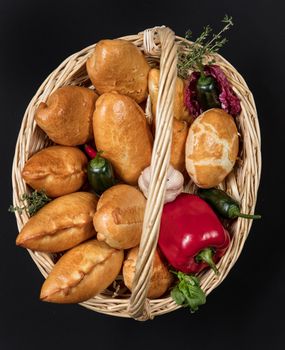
178,15,234,79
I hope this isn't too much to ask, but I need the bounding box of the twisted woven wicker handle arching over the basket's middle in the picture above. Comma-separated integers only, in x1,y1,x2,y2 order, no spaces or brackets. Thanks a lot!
128,27,177,320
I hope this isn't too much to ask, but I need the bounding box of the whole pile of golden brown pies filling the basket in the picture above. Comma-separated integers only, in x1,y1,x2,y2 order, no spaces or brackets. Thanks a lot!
16,39,238,303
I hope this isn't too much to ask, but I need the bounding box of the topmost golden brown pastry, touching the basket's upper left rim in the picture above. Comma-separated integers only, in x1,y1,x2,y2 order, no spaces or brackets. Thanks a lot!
86,39,150,103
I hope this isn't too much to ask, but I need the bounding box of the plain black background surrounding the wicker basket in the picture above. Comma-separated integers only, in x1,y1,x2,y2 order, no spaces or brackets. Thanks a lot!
0,0,285,350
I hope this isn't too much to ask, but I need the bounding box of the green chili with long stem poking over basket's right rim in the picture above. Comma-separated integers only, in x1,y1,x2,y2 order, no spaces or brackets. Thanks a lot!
198,188,261,219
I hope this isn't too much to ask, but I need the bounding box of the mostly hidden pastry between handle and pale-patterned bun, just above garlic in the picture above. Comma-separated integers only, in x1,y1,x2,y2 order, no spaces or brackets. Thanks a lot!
170,119,189,173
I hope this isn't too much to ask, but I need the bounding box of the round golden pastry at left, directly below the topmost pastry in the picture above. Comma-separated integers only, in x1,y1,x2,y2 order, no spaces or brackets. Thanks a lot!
35,86,98,146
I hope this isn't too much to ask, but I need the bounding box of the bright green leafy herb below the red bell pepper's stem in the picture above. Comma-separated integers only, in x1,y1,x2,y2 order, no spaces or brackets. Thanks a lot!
170,271,206,312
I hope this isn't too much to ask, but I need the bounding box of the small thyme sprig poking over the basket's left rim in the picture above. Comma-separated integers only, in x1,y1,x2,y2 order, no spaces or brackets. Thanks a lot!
8,190,51,216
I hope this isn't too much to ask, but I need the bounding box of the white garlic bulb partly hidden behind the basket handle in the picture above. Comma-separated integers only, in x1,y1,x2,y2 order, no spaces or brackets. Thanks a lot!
138,165,184,203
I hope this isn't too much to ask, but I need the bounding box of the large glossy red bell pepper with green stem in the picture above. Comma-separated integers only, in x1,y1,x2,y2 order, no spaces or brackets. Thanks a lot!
158,193,230,274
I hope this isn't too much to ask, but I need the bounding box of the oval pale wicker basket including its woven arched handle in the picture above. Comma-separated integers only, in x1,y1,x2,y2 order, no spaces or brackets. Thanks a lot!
12,27,261,320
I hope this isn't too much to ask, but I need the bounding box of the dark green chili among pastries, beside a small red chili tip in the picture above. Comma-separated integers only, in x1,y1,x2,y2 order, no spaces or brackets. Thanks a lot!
87,152,115,195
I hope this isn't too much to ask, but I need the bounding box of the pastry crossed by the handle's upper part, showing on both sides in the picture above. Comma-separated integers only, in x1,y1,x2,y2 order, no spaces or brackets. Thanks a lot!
148,68,193,123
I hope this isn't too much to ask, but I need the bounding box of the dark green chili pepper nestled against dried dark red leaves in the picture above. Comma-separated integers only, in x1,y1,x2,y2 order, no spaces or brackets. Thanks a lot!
196,64,221,111
